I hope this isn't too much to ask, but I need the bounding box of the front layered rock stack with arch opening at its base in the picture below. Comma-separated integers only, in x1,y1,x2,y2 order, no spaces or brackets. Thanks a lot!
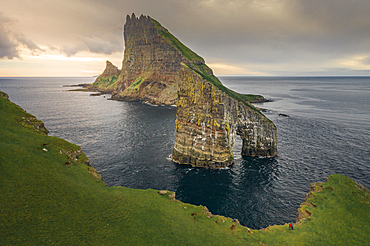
172,64,277,168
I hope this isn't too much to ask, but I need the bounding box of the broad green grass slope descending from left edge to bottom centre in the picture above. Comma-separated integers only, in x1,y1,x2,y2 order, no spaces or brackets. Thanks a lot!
0,92,258,245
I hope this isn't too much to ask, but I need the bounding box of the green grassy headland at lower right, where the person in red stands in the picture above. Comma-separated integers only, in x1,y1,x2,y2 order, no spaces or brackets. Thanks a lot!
254,174,370,245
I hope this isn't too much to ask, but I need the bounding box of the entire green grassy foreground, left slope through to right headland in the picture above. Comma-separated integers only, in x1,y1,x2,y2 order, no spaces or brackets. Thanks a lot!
0,93,370,245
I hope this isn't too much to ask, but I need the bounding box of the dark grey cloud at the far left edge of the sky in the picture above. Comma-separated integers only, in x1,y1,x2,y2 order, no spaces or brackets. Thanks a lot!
0,11,43,59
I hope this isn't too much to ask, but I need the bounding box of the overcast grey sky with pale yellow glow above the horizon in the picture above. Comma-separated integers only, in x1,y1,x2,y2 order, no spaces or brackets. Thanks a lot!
0,0,370,76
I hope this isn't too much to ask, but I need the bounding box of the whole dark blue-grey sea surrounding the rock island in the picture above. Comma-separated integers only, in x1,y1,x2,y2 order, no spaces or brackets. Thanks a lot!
0,77,370,228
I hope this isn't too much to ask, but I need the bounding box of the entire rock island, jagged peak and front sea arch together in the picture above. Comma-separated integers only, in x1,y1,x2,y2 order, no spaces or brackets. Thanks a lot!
92,14,277,168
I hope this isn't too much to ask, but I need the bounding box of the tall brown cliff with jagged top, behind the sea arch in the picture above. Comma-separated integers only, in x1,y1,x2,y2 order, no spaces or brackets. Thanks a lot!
93,14,205,105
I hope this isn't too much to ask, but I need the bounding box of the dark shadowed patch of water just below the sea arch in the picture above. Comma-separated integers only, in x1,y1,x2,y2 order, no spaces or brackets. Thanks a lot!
174,157,294,229
